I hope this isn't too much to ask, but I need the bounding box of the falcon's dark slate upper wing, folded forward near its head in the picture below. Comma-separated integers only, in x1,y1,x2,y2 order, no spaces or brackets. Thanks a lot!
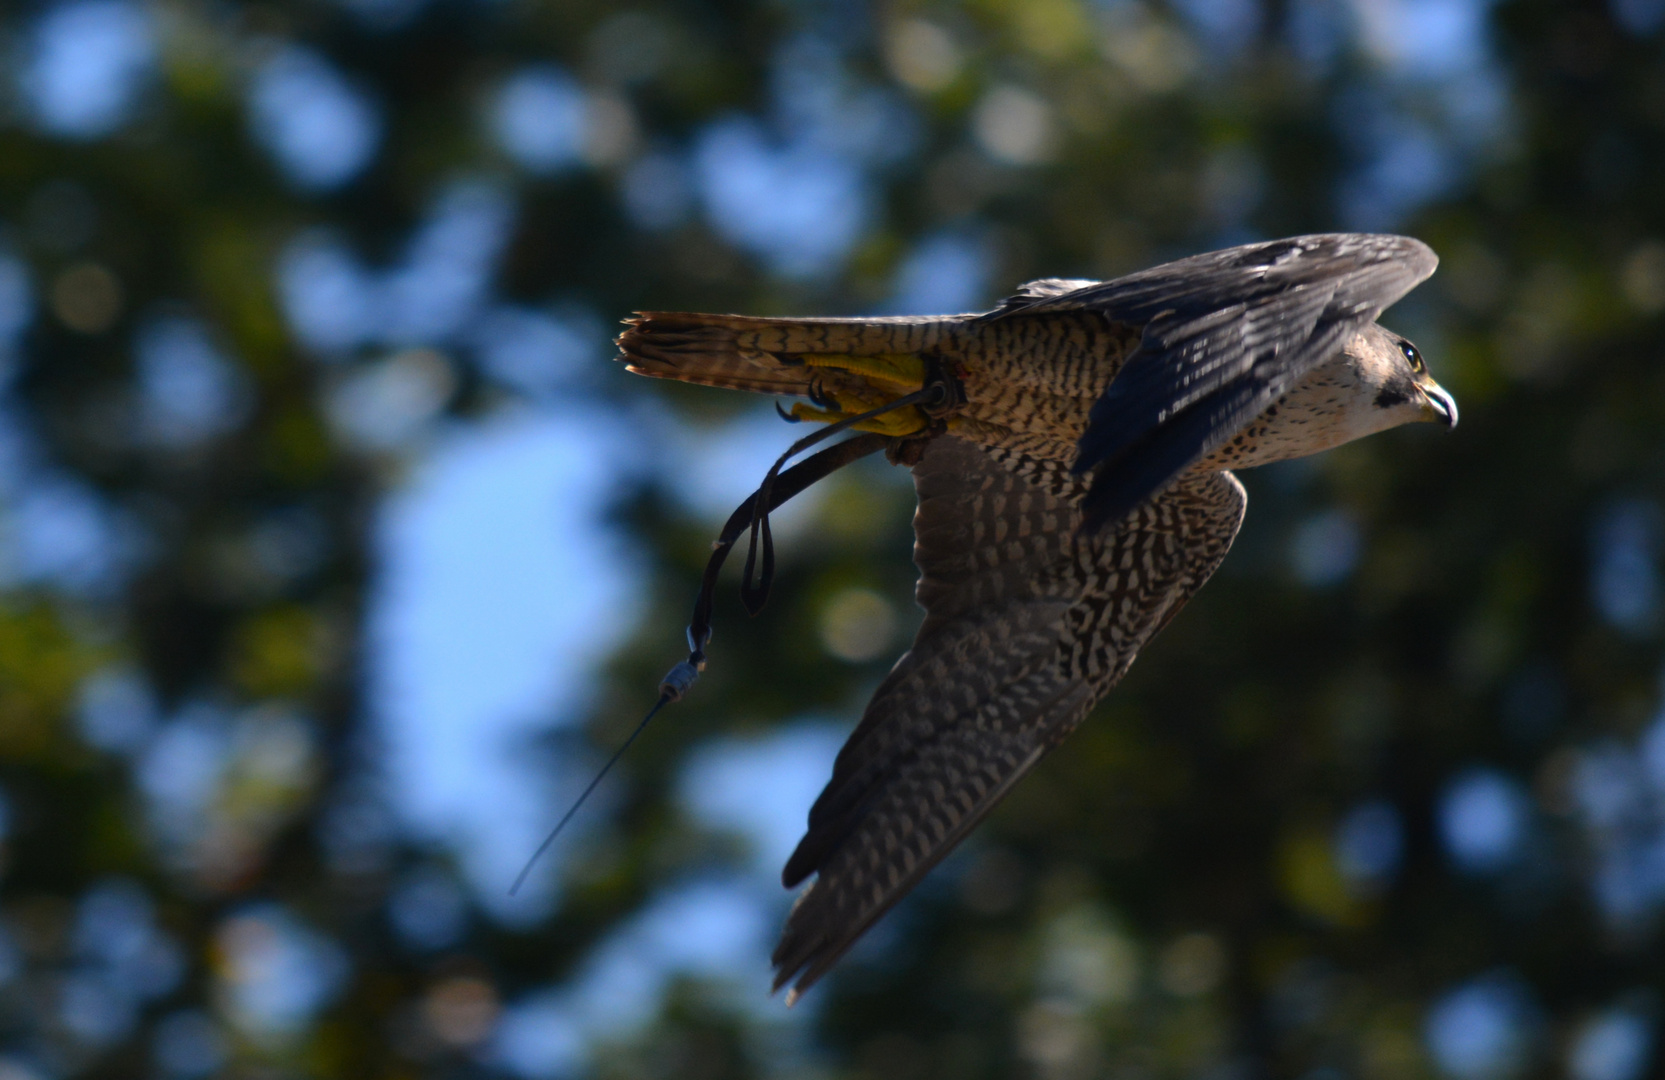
984,233,1439,528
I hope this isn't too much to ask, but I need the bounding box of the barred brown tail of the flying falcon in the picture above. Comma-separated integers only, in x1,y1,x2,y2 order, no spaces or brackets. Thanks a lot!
618,311,964,394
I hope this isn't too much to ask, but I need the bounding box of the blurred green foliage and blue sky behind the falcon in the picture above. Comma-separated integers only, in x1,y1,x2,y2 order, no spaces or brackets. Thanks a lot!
0,0,1665,1080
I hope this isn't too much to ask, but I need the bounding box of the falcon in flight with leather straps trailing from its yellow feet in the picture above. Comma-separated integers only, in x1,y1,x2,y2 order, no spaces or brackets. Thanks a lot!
618,233,1457,1002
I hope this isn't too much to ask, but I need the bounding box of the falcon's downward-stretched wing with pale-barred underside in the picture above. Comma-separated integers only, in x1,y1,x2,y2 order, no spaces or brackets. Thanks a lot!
774,436,1245,997
